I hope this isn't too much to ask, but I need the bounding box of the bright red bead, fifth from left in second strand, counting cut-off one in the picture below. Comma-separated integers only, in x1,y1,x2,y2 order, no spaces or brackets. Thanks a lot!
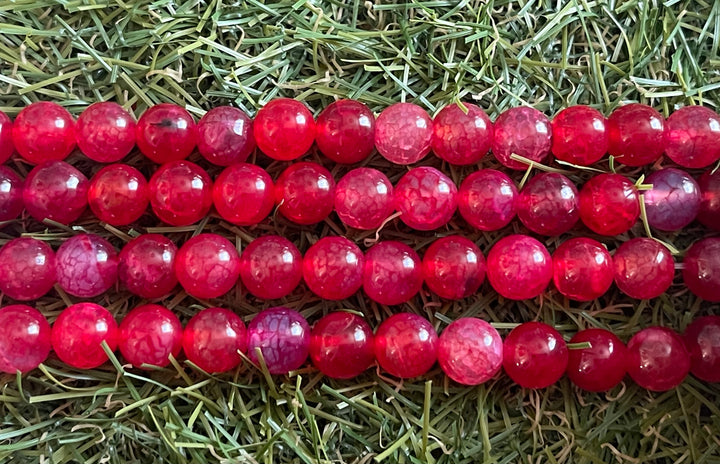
212,163,275,226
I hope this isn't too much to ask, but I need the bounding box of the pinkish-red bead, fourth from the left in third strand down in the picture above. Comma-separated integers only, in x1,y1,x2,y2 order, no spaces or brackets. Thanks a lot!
175,234,240,298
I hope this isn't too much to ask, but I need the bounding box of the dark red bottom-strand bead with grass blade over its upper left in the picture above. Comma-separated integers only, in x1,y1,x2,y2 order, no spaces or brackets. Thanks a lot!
567,329,628,392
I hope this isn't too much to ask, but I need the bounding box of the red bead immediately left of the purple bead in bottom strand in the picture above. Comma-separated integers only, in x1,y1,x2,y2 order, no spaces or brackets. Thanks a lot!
182,308,247,373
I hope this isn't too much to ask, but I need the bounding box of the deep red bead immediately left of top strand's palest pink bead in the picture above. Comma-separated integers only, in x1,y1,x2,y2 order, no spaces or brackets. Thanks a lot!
315,100,375,164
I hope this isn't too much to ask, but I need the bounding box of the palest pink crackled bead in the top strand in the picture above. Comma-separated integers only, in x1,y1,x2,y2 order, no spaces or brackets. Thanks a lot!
375,103,433,164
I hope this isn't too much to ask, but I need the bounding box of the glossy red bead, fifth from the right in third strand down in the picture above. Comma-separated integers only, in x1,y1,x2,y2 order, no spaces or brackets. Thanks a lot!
422,235,485,300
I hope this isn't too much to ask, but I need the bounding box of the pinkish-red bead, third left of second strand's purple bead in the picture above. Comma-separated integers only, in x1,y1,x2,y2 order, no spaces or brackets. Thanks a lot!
458,169,518,231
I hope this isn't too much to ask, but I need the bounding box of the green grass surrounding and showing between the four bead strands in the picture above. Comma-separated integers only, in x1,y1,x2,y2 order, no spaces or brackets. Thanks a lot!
0,0,720,464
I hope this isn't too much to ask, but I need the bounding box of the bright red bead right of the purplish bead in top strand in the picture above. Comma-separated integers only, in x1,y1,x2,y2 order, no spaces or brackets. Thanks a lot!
253,98,315,161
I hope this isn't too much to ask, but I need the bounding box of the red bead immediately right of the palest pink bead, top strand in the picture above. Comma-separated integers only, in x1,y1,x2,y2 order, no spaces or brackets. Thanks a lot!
432,103,493,165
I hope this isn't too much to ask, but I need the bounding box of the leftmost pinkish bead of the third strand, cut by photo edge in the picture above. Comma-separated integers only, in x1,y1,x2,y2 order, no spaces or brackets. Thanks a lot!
0,237,55,301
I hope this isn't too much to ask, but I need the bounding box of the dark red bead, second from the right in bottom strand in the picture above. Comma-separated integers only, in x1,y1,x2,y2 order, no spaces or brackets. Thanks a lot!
628,327,690,391
